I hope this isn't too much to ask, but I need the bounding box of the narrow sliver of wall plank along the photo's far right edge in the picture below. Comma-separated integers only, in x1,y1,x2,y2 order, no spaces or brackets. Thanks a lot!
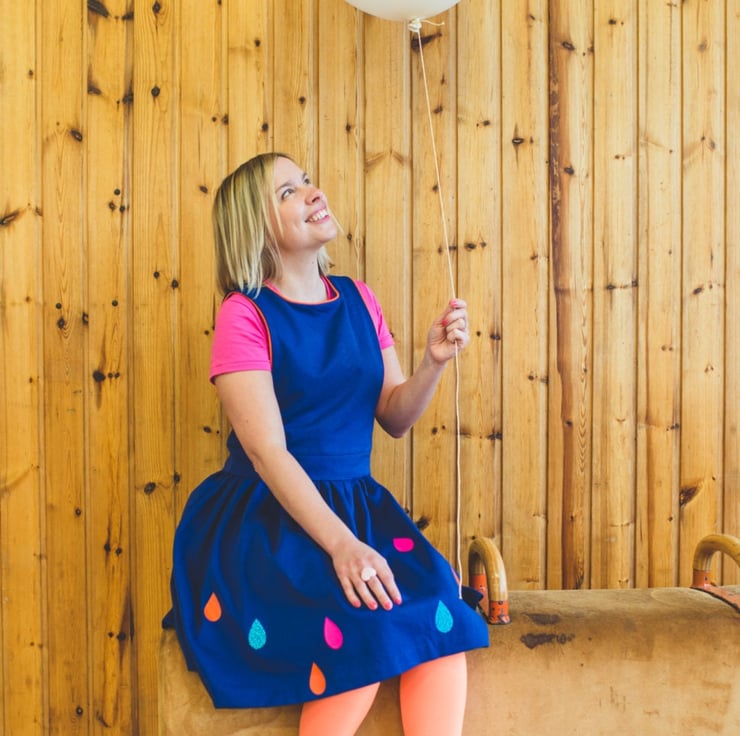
723,3,740,585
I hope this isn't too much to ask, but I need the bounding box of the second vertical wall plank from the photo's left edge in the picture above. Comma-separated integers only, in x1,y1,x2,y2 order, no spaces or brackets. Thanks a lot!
40,3,92,735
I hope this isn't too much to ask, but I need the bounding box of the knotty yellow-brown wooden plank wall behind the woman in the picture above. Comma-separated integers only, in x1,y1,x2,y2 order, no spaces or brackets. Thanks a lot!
0,0,740,736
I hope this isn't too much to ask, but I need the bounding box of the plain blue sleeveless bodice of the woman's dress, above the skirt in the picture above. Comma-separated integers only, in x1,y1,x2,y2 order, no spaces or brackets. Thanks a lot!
226,276,383,479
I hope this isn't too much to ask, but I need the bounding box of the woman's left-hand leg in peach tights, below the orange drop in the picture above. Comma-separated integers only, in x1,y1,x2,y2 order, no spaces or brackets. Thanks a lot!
298,682,380,736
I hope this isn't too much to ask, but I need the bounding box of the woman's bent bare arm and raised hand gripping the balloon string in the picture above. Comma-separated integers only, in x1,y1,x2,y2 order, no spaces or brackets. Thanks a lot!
375,299,470,437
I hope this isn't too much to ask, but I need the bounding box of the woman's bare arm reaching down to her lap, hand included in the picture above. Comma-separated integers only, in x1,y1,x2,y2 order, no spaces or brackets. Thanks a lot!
215,370,401,608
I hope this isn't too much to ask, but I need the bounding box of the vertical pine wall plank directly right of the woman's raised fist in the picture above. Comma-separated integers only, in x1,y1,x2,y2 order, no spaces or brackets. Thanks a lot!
455,0,503,560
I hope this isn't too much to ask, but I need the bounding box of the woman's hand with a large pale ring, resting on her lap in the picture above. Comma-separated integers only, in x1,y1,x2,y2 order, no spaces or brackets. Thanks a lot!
331,538,402,611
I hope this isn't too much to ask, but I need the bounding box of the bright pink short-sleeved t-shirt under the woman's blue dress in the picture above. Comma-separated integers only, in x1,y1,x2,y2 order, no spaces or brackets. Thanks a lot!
210,281,393,381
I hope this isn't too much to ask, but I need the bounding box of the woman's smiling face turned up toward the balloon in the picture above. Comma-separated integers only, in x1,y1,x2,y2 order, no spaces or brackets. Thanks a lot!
273,157,337,253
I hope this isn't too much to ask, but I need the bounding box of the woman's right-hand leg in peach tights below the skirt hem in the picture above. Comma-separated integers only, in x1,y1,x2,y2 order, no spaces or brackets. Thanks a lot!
400,652,468,736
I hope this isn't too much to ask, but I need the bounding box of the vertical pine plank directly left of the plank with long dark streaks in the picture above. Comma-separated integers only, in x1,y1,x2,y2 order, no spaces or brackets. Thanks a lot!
500,2,550,588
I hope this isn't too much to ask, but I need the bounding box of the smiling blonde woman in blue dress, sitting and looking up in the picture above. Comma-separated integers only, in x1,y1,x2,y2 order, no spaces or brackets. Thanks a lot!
166,153,488,736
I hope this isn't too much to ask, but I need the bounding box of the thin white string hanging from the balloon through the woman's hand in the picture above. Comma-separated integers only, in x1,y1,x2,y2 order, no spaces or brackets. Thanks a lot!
409,18,462,598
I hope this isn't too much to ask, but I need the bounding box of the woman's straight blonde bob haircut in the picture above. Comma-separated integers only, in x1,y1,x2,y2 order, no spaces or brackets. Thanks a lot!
212,152,331,294
